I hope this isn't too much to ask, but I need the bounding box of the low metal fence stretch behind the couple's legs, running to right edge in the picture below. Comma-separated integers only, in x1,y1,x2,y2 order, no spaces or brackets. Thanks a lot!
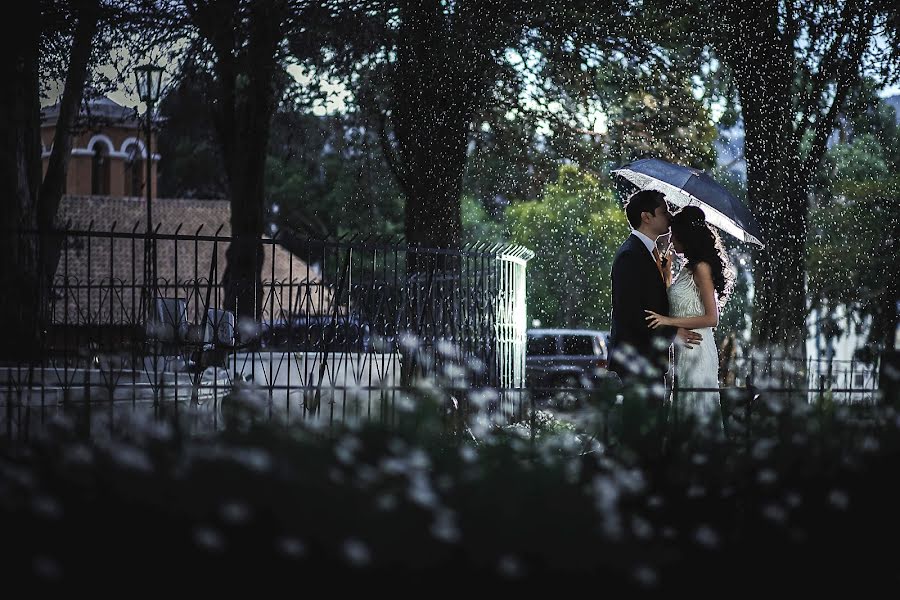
528,352,884,443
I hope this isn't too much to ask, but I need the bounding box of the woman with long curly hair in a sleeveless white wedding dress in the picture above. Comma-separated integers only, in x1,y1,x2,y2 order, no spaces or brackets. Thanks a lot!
644,206,734,433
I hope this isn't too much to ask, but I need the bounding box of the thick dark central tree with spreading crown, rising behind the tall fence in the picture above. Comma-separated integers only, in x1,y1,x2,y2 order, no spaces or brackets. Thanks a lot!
292,0,660,247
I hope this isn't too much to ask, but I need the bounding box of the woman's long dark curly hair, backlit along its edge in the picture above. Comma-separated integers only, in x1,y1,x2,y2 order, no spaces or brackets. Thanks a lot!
670,206,734,308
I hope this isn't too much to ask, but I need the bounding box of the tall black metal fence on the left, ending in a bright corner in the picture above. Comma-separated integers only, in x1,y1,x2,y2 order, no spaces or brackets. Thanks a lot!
0,226,532,435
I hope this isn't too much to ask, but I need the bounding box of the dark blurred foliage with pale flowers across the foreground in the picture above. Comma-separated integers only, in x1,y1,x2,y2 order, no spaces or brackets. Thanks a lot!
0,378,900,592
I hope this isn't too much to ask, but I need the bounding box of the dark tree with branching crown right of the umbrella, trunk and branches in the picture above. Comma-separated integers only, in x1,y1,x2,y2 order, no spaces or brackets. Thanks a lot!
684,0,900,366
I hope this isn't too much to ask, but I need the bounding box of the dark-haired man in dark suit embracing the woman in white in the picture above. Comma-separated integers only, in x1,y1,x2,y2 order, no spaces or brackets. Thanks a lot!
609,190,702,408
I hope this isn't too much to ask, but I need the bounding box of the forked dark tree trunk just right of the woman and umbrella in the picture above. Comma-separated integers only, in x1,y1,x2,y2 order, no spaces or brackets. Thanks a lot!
712,2,874,387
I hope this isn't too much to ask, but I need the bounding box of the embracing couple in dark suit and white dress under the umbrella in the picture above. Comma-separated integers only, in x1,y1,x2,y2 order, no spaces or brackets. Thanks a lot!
609,190,734,433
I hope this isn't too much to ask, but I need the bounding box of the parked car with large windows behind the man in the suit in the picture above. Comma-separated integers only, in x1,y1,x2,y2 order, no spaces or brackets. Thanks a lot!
525,329,609,404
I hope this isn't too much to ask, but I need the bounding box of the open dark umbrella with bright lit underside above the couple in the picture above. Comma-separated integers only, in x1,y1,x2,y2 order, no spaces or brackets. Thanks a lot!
612,158,764,248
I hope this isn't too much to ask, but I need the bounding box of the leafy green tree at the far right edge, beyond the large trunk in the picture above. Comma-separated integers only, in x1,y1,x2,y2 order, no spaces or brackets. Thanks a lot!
807,87,900,360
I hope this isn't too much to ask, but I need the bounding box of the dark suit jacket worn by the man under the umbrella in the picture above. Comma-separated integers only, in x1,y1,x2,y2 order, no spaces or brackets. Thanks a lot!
609,235,677,379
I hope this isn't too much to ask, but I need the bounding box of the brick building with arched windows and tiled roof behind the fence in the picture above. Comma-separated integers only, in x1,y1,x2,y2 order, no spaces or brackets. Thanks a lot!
41,98,330,325
